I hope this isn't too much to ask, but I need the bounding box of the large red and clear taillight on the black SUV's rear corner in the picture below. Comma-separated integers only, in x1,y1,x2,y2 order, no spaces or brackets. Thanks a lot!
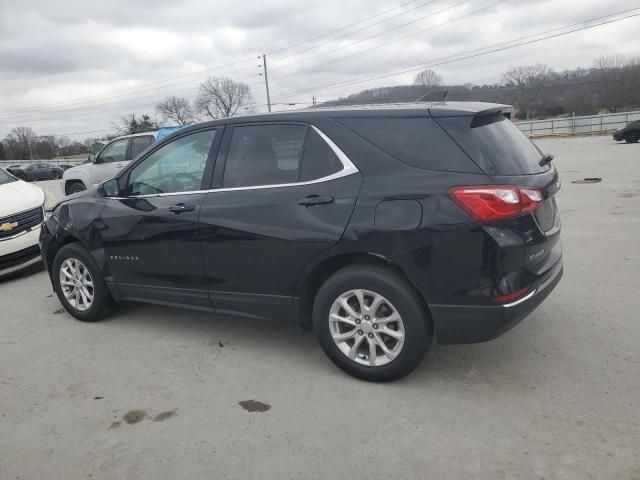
447,185,544,223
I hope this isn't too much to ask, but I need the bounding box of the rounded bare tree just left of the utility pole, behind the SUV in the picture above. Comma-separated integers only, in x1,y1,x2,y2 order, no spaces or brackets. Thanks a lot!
196,77,253,120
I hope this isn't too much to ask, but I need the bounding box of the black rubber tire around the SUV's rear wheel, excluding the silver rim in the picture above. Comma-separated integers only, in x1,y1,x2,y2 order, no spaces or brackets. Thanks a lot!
313,265,433,382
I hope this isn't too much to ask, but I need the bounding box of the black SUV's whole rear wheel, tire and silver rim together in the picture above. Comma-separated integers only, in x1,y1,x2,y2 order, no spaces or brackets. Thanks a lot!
313,266,433,382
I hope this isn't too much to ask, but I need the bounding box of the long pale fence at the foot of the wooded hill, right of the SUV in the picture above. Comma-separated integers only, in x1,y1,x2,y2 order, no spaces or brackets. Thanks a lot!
516,111,640,137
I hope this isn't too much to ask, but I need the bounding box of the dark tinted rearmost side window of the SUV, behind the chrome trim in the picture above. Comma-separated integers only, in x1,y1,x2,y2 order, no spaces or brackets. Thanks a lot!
341,117,478,172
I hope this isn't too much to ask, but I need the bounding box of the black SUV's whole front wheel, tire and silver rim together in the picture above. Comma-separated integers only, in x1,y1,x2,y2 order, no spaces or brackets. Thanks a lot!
51,243,112,322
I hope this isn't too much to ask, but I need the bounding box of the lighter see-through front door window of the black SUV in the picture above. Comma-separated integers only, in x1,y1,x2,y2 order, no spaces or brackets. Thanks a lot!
128,130,216,195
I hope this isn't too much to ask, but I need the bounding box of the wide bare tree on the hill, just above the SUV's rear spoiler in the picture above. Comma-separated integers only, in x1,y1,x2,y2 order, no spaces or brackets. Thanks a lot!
502,63,553,120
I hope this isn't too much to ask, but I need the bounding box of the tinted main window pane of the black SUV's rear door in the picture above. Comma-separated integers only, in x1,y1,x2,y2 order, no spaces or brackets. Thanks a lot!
223,125,306,188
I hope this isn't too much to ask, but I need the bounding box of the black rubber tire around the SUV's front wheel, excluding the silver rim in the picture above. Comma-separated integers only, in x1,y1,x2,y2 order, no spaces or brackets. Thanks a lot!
51,243,113,322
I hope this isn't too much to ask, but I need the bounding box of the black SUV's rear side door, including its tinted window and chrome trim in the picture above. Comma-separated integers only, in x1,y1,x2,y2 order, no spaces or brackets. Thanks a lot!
200,123,362,321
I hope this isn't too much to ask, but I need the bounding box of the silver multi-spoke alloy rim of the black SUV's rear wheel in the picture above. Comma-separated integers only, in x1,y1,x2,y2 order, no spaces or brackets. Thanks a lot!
329,289,405,367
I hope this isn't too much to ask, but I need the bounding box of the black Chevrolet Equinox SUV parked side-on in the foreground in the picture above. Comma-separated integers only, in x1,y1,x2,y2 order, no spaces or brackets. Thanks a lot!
41,103,562,381
